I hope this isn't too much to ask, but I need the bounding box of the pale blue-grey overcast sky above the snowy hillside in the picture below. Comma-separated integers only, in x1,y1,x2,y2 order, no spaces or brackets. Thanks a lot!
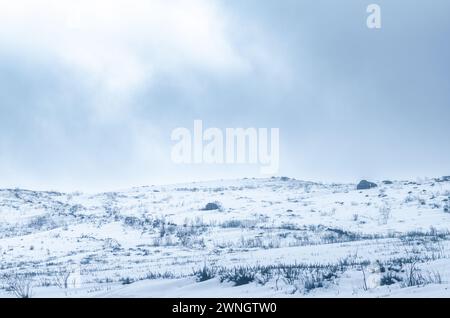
0,0,450,191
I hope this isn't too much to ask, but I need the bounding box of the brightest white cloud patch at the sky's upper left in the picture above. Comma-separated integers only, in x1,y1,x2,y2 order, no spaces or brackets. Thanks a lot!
0,0,247,115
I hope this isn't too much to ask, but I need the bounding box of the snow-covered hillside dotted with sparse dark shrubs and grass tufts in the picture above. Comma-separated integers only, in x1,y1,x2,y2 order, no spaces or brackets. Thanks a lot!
0,178,450,297
